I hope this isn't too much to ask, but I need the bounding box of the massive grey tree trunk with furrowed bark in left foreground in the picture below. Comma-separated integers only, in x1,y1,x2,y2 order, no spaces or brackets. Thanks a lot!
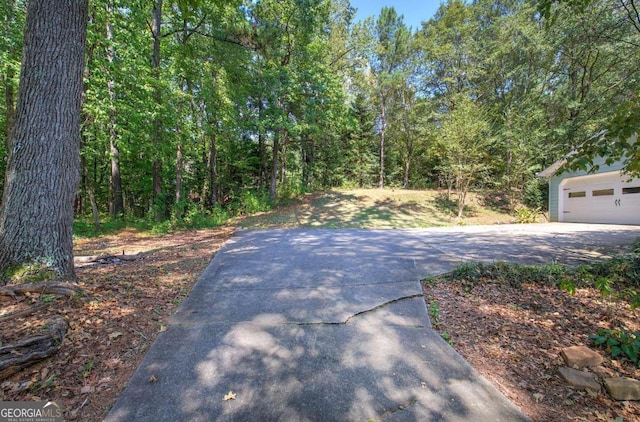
0,0,88,283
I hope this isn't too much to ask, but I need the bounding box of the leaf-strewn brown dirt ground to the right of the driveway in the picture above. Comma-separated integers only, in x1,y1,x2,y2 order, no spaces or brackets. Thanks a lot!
424,280,640,421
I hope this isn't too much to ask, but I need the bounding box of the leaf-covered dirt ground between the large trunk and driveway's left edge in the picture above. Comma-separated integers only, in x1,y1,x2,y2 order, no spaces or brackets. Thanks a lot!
0,227,233,421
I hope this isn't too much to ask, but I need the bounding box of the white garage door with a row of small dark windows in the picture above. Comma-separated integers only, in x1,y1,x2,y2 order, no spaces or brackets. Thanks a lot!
559,172,640,224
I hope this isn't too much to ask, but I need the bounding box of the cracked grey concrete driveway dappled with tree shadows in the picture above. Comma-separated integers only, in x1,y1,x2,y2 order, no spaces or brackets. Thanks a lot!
107,224,640,421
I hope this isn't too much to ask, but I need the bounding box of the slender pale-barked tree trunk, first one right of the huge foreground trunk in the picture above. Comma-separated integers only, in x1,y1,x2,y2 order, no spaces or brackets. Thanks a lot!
105,4,124,218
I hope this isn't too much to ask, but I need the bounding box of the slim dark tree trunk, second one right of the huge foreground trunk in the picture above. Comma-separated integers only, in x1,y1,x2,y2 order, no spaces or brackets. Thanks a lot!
151,0,167,220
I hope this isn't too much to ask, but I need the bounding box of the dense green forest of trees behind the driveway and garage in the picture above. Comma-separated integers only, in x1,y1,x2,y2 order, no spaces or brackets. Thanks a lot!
0,0,640,227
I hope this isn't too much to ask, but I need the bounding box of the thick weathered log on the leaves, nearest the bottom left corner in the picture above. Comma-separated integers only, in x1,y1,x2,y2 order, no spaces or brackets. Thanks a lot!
0,317,68,381
